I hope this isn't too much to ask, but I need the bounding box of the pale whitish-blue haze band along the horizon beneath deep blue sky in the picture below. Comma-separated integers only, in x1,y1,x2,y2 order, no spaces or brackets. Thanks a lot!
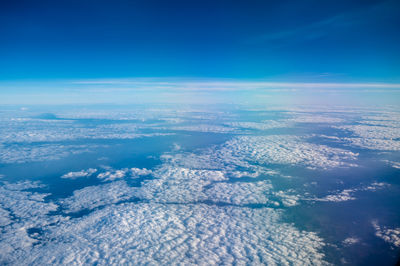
0,78,400,104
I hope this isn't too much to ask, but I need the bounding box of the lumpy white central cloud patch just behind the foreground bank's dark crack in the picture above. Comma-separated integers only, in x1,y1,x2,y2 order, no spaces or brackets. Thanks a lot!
125,165,299,207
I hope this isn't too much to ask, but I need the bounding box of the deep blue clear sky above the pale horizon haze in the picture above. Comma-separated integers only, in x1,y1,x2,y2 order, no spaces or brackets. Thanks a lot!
0,0,400,82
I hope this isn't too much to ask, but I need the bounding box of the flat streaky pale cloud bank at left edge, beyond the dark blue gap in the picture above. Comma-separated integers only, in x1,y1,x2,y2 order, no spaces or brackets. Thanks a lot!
0,115,177,164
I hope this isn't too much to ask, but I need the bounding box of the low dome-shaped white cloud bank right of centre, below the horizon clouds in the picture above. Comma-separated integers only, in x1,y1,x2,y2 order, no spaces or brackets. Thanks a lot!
161,135,358,171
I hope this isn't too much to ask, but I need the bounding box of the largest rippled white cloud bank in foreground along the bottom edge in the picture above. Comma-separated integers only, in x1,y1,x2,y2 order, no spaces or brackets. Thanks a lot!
11,203,326,265
